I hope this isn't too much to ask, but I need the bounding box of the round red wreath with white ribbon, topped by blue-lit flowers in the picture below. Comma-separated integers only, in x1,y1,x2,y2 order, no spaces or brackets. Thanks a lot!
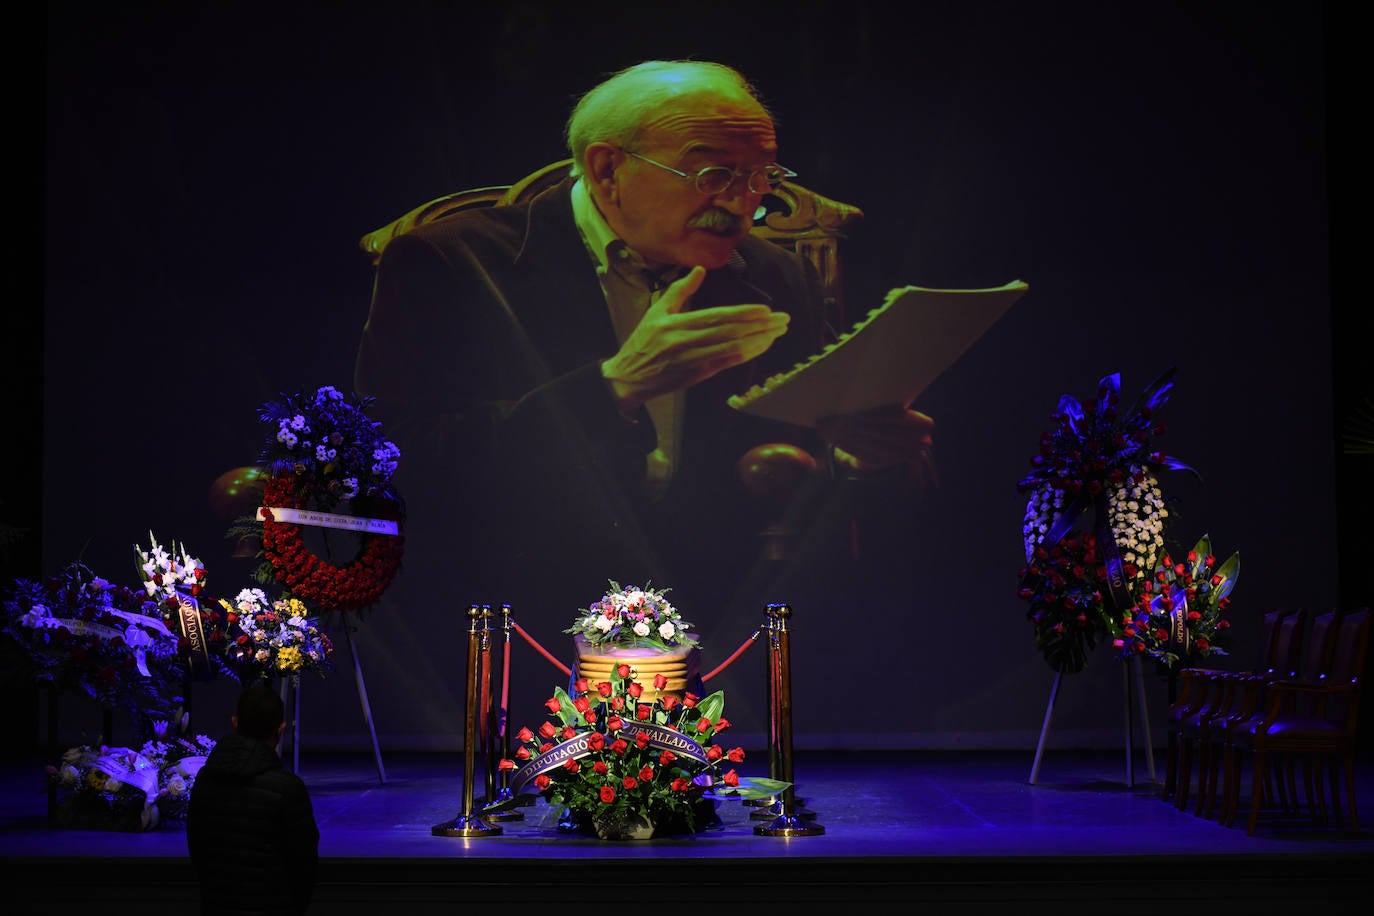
258,386,405,610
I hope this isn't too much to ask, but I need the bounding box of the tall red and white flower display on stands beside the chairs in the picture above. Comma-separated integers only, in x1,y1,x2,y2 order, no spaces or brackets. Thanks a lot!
1018,368,1239,673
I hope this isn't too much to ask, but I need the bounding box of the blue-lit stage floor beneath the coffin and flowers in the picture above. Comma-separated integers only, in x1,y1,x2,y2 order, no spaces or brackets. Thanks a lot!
0,748,1374,916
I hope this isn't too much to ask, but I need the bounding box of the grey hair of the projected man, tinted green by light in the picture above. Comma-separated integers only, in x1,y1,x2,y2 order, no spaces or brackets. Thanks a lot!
566,60,772,176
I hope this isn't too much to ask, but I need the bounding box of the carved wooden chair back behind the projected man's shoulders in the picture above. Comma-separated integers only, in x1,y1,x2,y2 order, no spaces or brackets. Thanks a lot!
359,159,863,339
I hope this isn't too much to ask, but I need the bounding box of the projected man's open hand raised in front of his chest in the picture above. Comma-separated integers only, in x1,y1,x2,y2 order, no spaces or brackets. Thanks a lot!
602,266,790,415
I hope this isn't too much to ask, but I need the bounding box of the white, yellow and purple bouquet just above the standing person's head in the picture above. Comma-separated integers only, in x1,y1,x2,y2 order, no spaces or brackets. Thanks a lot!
220,588,334,681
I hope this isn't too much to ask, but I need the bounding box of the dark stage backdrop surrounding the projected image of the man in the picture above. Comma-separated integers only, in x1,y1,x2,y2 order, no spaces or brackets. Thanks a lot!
34,0,1337,750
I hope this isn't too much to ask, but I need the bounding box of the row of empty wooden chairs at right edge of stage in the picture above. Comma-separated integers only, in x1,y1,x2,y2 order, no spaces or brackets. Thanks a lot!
1164,608,1370,835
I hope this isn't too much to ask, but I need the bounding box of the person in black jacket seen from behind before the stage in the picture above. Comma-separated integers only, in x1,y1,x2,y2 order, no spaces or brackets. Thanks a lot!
185,684,320,916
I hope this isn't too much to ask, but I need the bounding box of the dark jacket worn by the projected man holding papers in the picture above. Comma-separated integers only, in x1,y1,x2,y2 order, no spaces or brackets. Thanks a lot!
356,183,823,619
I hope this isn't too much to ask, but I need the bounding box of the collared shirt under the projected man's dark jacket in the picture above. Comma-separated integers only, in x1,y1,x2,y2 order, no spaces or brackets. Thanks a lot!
572,180,684,497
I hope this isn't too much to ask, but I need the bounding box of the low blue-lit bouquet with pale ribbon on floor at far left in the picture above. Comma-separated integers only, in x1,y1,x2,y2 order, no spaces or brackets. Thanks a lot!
48,715,214,831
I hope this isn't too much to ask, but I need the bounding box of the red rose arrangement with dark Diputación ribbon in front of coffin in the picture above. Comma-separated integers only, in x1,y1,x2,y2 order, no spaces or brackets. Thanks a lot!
494,663,789,839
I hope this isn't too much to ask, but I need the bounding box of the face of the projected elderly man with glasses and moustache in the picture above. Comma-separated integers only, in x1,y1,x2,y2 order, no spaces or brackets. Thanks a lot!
603,98,778,269
